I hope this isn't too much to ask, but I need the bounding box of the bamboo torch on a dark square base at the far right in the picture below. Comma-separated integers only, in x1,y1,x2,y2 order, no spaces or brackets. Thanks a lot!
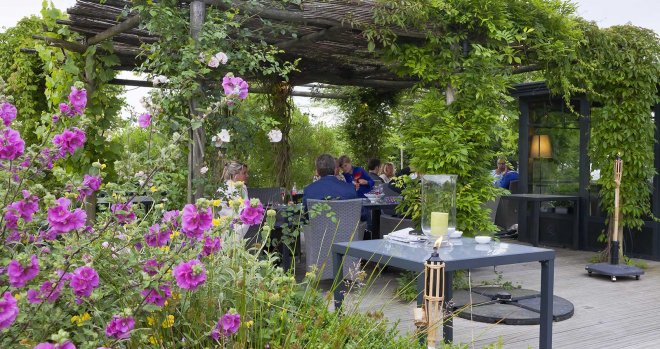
585,155,644,281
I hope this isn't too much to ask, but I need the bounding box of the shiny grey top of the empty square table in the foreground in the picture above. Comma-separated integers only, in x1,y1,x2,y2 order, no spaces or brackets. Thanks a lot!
332,238,555,272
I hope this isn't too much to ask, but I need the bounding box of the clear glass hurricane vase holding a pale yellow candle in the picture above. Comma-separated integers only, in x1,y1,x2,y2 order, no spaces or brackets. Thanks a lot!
422,174,458,238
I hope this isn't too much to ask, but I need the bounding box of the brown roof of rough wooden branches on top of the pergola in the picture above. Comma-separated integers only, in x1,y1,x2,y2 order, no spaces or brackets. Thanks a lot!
52,0,425,89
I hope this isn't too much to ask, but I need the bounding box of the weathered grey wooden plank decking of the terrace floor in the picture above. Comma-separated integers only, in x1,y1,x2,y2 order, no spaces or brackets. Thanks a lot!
338,245,660,349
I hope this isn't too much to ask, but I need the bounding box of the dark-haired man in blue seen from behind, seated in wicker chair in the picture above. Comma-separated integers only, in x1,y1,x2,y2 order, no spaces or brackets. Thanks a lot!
303,154,357,208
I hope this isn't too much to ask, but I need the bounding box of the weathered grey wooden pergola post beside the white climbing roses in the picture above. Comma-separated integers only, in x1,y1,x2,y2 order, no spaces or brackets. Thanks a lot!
188,0,206,203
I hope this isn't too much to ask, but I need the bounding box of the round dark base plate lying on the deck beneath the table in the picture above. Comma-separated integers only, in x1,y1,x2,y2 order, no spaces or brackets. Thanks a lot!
452,287,574,325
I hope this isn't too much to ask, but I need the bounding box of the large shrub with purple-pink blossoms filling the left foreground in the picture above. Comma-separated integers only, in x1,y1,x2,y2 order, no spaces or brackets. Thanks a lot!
0,73,426,349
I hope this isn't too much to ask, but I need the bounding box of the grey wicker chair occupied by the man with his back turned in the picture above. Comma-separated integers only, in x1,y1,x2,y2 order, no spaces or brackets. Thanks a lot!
303,199,366,280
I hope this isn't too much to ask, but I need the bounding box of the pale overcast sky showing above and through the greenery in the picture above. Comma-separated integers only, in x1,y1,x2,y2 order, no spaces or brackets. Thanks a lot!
0,0,660,121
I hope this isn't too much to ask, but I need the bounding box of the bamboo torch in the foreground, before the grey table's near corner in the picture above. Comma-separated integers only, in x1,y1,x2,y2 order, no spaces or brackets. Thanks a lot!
415,237,445,347
